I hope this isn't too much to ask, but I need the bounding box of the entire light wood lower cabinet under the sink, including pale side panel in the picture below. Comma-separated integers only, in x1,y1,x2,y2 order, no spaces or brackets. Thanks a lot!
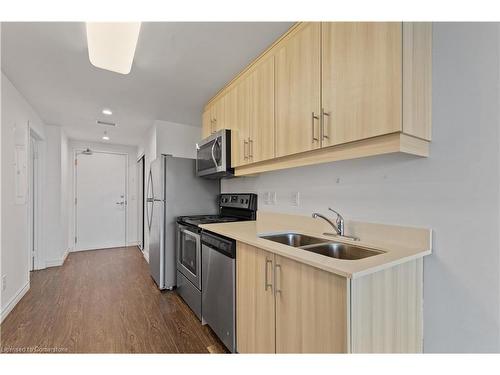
236,242,423,353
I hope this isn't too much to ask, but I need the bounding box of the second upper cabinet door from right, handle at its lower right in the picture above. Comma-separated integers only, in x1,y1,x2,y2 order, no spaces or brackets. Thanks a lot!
275,23,320,156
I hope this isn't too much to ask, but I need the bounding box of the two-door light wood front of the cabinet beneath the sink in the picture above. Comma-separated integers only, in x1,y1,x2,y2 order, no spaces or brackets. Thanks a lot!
236,243,347,353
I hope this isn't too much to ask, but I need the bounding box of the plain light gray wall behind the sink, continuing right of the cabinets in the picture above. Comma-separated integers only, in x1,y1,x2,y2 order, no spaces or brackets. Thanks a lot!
222,23,500,352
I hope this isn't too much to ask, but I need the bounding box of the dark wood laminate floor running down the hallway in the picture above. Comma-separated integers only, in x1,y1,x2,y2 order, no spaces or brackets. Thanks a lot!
0,247,224,353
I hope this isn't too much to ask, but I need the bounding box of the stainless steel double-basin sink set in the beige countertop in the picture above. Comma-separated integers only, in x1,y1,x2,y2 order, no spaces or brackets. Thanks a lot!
260,233,383,260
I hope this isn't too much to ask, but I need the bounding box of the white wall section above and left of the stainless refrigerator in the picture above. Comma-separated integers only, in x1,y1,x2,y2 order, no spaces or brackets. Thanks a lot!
137,121,201,259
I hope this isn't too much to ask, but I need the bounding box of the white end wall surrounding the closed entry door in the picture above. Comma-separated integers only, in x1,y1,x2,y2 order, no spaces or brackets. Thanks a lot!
66,140,138,250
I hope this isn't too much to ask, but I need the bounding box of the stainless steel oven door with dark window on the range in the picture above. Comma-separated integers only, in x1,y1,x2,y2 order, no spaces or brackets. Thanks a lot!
177,225,201,290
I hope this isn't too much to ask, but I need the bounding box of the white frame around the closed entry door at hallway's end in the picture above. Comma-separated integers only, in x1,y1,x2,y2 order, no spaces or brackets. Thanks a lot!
71,148,129,252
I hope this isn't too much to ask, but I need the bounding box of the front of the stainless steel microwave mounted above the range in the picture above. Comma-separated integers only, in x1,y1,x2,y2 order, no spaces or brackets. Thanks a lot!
196,130,228,176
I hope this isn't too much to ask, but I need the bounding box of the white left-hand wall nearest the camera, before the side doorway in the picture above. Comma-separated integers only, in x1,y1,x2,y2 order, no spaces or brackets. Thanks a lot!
0,73,45,318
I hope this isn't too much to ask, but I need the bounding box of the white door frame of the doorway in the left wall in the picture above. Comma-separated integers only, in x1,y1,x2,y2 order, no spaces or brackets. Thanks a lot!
26,125,46,271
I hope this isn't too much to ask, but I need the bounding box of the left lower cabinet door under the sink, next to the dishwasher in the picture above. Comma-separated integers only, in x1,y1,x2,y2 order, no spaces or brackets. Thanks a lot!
236,242,275,353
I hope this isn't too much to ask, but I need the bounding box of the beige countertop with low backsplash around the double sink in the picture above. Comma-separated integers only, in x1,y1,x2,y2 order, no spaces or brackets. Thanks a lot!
201,213,432,278
